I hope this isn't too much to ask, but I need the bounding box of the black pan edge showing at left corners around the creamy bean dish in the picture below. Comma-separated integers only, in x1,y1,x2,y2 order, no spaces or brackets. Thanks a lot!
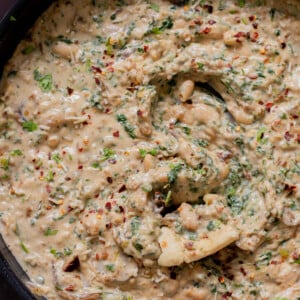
0,0,53,300
